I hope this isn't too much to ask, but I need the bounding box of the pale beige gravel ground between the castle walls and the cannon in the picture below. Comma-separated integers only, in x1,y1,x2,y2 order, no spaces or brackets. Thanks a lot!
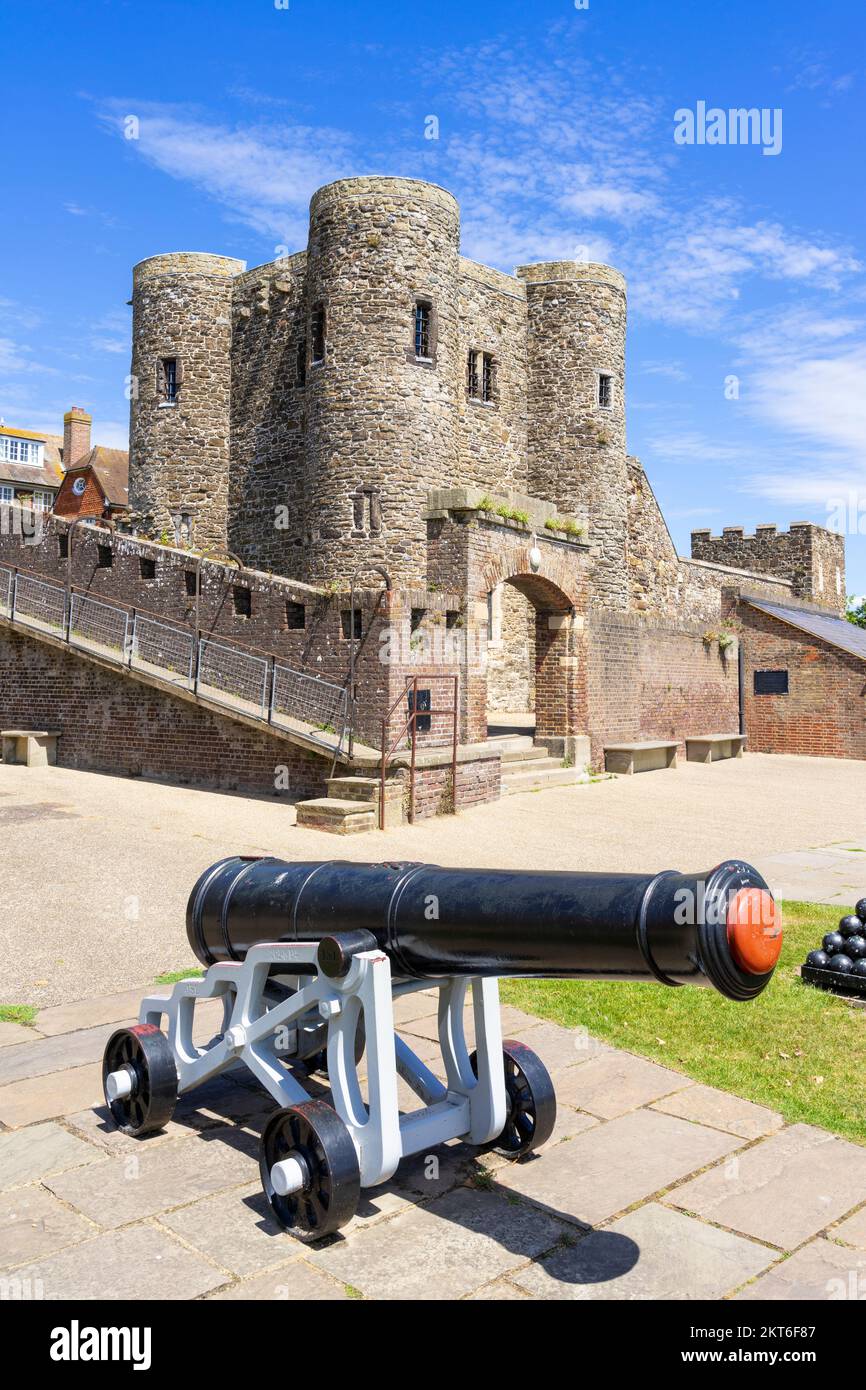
0,753,866,1006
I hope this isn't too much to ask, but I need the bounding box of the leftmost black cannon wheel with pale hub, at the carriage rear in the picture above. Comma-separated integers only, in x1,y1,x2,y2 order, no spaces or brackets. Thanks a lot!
103,1023,178,1136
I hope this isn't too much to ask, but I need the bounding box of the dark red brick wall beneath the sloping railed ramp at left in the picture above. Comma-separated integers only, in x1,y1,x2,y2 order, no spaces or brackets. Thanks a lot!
0,627,328,801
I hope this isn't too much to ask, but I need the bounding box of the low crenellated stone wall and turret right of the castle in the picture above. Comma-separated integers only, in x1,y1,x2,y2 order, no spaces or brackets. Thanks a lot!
692,521,845,613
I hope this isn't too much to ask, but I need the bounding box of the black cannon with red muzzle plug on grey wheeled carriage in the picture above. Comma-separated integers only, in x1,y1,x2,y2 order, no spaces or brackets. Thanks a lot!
103,858,781,1240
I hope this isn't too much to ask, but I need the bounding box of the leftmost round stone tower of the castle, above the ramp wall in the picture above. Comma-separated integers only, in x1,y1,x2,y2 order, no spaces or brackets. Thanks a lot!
129,252,245,550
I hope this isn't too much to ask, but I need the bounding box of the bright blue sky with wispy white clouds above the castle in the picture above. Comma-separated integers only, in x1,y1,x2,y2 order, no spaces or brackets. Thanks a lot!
0,0,866,594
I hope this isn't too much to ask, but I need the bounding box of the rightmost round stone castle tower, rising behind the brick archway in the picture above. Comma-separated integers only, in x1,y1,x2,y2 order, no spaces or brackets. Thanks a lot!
517,261,628,607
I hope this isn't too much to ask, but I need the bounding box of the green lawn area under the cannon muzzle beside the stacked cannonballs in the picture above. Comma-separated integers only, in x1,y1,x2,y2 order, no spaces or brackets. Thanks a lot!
502,902,866,1144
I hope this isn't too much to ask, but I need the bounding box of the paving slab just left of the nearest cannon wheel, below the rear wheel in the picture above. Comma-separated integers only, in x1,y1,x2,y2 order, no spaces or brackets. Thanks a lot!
46,1129,259,1227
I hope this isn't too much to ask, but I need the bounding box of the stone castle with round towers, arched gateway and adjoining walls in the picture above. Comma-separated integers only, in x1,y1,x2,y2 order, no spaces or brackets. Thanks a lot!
0,177,866,815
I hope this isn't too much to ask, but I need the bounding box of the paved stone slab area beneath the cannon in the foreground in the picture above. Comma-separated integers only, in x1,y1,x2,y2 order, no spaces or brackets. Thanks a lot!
0,990,866,1300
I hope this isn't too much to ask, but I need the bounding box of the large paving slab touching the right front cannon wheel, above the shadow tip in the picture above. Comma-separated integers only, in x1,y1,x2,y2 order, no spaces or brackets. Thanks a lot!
496,1111,741,1225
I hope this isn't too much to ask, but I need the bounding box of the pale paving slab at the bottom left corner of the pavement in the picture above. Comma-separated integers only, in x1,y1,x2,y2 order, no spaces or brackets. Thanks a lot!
15,1226,227,1302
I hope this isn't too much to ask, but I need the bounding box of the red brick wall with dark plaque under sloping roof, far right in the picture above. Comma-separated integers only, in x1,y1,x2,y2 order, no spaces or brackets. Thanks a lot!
740,605,866,758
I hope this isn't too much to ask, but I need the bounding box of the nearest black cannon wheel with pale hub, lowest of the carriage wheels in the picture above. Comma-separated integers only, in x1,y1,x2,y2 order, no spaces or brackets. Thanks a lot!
259,1101,361,1243
